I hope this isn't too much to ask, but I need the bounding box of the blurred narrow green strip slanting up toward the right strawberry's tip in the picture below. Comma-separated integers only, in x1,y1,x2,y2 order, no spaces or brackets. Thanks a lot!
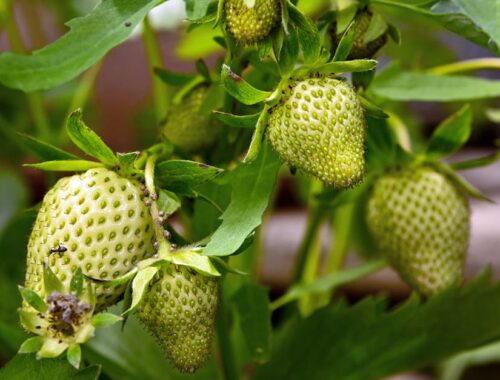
271,260,387,310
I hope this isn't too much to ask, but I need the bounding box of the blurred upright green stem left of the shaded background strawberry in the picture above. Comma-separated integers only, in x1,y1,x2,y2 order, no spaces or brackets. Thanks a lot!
142,16,171,125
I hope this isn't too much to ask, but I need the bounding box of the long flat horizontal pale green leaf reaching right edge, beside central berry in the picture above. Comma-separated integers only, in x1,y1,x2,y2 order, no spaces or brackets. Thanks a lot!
368,67,500,102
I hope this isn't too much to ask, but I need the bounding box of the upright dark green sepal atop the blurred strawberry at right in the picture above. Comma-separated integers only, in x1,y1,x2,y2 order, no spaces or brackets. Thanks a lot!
427,105,472,159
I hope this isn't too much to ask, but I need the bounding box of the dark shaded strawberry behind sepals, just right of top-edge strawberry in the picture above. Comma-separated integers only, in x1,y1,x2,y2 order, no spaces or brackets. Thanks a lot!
330,9,387,59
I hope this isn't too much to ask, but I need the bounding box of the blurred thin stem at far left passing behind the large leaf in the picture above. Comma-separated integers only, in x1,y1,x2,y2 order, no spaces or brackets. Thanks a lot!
5,4,50,141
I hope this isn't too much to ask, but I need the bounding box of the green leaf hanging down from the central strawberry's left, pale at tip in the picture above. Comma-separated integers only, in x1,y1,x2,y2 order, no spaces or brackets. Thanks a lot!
203,143,281,256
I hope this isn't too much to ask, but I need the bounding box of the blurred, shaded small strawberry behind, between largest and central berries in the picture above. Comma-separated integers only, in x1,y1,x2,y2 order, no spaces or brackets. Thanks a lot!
163,85,219,152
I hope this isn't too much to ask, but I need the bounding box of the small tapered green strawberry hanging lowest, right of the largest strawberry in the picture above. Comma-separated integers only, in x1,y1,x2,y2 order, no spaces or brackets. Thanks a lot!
137,264,219,373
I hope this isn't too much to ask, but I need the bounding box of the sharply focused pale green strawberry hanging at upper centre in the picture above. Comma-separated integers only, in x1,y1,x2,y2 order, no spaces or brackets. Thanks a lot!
268,76,365,187
